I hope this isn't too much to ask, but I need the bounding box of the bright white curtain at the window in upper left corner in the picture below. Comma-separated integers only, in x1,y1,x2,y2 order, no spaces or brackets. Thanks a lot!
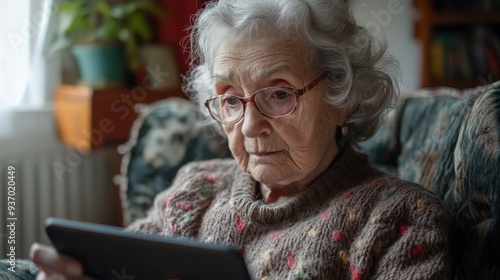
0,0,60,137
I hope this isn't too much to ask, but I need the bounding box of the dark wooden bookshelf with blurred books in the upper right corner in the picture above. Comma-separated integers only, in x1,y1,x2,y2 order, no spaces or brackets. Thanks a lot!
414,0,500,88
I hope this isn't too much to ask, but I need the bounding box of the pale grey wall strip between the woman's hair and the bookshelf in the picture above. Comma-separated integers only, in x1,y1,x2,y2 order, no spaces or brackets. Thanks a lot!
352,0,422,92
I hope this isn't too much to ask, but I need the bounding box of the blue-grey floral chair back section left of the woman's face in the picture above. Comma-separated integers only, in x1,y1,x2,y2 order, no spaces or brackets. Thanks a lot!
120,98,230,224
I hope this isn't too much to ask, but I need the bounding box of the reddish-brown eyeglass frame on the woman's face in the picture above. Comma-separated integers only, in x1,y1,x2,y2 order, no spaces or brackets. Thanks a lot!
205,72,328,125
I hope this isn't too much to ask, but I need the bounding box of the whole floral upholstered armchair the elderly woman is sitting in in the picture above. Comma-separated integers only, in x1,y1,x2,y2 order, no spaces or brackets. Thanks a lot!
0,82,500,279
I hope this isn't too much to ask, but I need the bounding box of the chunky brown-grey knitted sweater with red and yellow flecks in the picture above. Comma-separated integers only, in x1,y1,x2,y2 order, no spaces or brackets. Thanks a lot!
129,149,449,280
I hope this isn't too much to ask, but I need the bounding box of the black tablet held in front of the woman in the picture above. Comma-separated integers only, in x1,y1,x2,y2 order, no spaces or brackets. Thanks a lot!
45,218,250,280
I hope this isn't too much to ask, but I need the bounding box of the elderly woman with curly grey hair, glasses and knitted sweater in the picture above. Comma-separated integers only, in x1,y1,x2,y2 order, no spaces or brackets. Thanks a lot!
32,0,449,280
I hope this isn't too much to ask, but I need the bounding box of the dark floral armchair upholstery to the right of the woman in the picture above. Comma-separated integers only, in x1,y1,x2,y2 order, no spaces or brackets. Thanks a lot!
361,82,500,279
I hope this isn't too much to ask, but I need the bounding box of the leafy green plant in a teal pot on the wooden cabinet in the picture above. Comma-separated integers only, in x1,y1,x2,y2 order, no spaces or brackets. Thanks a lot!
51,0,164,87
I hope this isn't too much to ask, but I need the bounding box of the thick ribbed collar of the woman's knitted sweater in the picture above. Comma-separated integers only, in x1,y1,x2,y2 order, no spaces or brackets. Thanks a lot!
231,147,381,224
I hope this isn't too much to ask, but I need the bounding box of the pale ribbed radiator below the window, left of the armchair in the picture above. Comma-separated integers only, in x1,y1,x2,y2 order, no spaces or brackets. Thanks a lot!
0,133,121,259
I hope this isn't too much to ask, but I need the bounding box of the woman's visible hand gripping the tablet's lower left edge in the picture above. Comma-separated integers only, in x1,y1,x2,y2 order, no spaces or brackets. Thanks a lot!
30,243,83,277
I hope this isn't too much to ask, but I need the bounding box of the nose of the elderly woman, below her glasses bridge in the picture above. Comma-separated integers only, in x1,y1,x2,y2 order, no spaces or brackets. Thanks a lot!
241,102,271,138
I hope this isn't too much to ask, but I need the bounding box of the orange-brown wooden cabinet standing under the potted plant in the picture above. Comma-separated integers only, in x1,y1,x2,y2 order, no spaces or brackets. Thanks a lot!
55,85,185,151
